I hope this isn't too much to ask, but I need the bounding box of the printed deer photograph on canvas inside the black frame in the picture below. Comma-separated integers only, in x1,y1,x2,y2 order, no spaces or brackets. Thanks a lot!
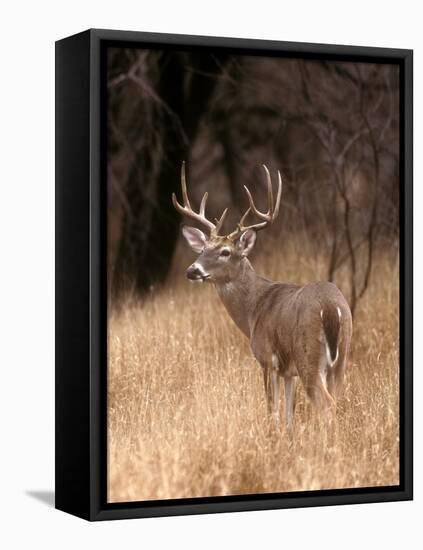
105,46,401,503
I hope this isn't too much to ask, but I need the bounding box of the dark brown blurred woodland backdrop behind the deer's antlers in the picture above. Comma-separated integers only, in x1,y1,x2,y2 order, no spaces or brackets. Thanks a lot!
108,49,399,311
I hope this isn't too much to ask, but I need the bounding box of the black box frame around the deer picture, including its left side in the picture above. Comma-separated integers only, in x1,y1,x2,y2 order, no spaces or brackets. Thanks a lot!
55,29,413,520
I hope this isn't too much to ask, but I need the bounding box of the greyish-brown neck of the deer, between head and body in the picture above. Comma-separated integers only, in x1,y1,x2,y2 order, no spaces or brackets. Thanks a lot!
216,258,270,338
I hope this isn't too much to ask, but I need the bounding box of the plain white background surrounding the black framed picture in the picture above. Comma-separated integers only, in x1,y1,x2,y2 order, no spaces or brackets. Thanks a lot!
0,0,423,550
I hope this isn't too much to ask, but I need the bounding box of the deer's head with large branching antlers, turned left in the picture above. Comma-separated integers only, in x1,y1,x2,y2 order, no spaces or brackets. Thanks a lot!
172,162,282,284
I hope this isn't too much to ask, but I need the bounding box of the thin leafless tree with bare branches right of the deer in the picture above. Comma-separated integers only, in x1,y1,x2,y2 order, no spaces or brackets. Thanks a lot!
299,62,395,313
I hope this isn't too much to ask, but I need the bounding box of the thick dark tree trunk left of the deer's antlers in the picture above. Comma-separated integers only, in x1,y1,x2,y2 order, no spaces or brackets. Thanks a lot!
113,52,229,293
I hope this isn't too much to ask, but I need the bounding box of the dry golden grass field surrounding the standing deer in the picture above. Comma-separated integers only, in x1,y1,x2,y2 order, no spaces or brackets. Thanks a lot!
108,238,399,502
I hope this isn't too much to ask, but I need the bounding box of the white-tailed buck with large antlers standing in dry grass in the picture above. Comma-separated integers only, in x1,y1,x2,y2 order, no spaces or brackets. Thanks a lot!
172,163,352,429
